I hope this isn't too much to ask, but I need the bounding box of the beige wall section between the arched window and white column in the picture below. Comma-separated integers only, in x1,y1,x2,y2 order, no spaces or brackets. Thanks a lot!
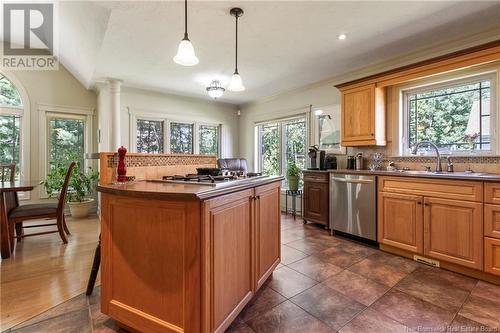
5,64,97,202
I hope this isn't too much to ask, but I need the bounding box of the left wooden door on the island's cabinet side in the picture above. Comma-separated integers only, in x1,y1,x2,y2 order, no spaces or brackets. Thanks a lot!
209,190,254,332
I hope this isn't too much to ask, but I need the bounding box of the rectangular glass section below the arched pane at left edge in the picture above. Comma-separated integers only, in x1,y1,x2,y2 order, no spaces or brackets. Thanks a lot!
0,114,21,179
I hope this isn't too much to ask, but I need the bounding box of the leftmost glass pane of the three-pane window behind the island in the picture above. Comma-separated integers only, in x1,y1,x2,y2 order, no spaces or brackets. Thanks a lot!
136,119,165,154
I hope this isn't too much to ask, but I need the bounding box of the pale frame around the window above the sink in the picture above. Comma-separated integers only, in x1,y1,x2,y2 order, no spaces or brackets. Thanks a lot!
397,68,500,156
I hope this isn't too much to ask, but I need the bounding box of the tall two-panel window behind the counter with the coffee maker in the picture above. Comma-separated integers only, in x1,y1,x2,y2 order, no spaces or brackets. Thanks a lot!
256,117,307,179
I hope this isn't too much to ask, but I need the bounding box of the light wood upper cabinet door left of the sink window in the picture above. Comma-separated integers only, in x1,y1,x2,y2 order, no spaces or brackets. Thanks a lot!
342,85,375,143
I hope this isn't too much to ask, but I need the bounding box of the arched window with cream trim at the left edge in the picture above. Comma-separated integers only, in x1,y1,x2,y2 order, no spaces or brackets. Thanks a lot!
0,73,29,179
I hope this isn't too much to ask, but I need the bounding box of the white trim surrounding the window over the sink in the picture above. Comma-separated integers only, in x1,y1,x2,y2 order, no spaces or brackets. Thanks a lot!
393,65,500,157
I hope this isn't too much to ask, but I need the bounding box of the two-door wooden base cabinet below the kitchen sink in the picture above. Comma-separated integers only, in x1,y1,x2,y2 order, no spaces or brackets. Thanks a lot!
378,177,484,270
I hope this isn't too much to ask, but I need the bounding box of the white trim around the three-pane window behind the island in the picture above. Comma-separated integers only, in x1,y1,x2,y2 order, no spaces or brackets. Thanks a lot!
129,108,223,157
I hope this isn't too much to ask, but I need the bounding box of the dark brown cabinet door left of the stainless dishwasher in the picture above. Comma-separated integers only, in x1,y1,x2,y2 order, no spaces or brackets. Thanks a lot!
304,180,329,226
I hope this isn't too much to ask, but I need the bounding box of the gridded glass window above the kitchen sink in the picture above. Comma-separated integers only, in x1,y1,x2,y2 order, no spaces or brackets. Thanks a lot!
404,75,496,153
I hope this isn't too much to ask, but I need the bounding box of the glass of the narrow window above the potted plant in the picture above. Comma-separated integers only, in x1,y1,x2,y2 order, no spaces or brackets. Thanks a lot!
47,115,86,171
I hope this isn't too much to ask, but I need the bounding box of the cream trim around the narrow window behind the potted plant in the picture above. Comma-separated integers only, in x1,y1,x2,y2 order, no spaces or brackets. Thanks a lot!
38,104,95,199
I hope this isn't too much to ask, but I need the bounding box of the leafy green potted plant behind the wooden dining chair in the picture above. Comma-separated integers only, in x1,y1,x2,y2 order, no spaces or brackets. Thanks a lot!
42,162,99,218
